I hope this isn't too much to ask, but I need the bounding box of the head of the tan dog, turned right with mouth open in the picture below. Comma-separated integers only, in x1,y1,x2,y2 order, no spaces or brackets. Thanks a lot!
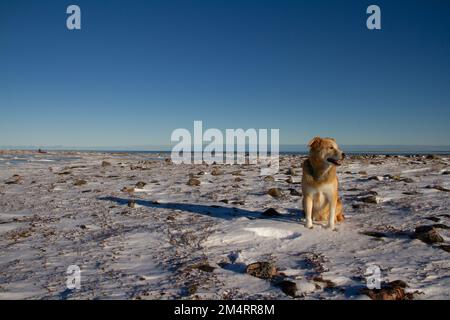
308,137,345,166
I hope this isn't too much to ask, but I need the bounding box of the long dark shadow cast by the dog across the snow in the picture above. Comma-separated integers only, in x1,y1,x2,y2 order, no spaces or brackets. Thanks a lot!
97,196,304,224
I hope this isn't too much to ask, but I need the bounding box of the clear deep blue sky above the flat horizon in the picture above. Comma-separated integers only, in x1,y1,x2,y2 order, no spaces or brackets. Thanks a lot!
0,0,450,147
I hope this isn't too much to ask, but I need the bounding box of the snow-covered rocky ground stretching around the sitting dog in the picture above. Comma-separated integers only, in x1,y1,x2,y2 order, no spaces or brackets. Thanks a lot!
0,151,450,299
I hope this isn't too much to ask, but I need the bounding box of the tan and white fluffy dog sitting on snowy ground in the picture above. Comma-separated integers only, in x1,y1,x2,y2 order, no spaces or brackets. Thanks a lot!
302,137,345,230
